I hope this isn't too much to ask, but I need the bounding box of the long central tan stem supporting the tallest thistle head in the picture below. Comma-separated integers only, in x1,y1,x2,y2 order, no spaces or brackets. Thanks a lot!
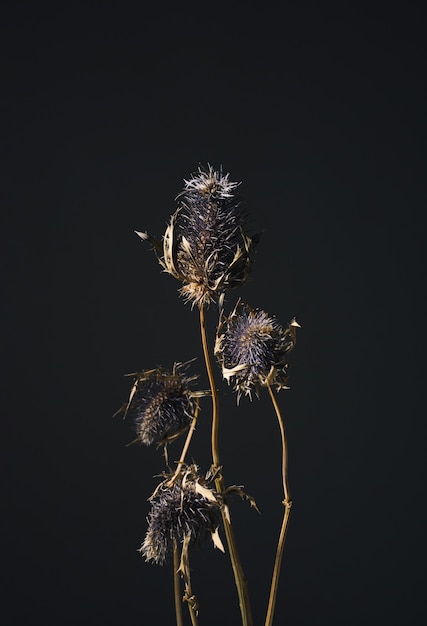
200,304,252,626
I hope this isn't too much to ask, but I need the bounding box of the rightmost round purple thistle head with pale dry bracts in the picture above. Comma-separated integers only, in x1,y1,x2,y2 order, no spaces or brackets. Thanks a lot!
215,301,300,400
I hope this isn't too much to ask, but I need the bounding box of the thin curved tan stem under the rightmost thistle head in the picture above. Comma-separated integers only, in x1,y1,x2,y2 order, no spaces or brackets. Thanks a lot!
265,380,292,626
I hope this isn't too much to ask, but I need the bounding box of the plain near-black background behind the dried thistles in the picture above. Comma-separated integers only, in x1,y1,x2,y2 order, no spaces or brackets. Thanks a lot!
0,2,426,626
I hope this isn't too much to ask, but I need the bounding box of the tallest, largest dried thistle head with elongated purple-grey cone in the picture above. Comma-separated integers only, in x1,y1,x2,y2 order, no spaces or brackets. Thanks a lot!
136,166,259,306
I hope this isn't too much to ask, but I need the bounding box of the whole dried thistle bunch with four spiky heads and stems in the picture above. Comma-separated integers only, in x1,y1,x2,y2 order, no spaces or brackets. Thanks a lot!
118,165,299,626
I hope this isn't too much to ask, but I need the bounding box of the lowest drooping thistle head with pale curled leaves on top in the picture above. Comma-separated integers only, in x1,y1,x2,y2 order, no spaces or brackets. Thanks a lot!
140,466,224,565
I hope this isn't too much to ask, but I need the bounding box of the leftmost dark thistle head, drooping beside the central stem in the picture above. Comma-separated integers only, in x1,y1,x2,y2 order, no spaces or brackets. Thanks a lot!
119,363,200,446
